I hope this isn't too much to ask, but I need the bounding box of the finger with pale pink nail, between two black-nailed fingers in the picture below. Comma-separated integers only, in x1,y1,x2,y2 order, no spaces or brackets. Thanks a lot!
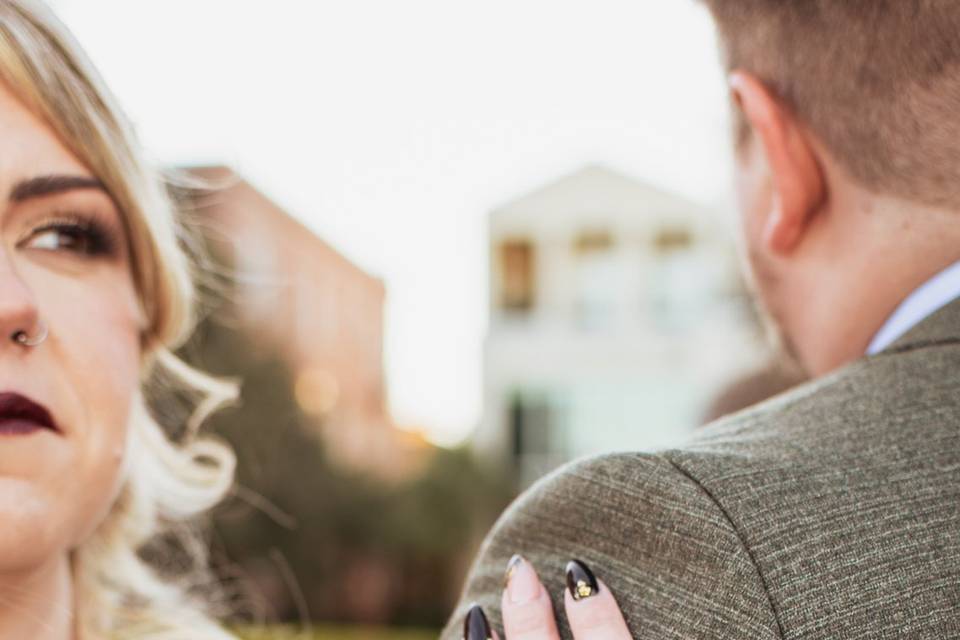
500,556,560,640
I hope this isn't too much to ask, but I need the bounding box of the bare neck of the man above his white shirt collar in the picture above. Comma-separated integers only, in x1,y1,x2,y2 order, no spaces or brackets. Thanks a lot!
781,192,960,377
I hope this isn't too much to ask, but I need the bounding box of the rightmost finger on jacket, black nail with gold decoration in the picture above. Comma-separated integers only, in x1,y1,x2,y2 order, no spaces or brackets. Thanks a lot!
564,560,631,640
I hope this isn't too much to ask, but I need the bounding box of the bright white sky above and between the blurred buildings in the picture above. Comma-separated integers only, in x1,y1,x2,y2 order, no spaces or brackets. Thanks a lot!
52,0,730,444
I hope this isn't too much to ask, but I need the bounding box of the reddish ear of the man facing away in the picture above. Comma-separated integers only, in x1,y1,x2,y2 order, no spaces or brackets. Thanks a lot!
729,70,826,254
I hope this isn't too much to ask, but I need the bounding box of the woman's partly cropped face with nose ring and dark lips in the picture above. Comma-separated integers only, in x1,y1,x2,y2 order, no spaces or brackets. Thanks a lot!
0,83,140,574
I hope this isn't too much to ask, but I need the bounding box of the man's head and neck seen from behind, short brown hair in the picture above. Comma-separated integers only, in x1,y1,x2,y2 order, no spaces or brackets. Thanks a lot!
704,0,960,375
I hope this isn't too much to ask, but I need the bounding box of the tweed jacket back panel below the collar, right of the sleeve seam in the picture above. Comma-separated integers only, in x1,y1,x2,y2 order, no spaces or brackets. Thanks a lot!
660,344,960,637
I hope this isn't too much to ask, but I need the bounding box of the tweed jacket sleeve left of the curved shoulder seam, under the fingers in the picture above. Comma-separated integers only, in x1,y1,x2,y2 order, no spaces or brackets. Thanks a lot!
442,452,778,640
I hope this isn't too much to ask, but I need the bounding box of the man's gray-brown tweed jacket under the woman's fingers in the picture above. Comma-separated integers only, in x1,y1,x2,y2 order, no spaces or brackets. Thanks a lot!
441,299,960,640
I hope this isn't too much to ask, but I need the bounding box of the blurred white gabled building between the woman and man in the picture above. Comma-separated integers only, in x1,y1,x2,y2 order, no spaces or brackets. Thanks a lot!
475,166,768,485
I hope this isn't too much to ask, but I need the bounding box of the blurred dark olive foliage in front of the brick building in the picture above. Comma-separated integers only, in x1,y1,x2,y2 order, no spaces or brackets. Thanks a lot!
144,218,515,627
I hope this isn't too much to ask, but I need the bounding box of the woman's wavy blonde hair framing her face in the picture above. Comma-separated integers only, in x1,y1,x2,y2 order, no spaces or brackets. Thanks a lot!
0,0,246,640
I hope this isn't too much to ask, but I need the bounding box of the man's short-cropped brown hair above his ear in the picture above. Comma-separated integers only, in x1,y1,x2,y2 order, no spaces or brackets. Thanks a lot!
704,0,960,207
